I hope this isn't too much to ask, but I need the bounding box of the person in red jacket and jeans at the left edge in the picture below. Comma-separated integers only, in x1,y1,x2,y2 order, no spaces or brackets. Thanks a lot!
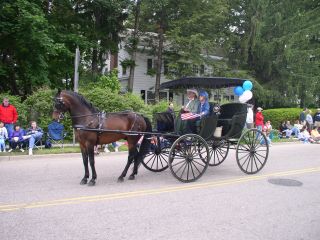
0,98,18,134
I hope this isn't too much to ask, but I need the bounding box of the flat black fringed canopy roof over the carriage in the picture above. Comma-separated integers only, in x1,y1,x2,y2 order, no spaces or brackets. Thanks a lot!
160,77,246,89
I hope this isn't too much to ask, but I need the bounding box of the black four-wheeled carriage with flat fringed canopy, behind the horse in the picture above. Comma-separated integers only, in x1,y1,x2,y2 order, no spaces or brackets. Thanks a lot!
142,77,269,182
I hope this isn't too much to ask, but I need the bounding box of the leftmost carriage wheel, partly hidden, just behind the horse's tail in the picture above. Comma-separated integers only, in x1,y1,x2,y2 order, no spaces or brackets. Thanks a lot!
142,144,170,172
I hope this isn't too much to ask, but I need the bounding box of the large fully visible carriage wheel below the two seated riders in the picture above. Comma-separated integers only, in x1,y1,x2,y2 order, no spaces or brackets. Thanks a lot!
169,134,210,183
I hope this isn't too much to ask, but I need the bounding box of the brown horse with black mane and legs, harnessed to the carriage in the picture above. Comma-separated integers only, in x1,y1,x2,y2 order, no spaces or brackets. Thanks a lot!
54,90,152,186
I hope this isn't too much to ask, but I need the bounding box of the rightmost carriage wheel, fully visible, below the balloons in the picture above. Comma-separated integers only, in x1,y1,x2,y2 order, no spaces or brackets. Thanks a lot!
236,129,269,174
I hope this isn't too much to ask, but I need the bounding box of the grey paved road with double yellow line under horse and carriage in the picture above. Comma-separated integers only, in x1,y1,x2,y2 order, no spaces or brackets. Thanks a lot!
0,143,320,240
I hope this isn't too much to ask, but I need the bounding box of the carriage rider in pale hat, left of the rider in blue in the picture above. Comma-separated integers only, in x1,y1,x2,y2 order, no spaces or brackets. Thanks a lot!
175,89,200,134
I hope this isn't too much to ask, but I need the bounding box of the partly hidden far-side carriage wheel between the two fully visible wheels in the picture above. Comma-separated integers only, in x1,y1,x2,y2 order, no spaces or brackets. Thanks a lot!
209,139,230,166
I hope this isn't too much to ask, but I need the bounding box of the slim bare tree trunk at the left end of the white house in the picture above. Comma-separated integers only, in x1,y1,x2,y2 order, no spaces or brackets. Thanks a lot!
128,0,141,92
